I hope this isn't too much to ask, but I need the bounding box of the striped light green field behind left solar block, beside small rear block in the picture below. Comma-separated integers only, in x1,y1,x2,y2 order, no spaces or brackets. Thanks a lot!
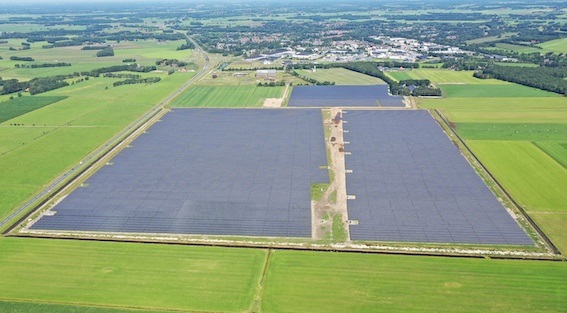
171,85,285,108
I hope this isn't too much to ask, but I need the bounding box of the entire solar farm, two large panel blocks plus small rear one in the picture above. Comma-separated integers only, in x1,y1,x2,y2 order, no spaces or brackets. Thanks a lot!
27,85,533,246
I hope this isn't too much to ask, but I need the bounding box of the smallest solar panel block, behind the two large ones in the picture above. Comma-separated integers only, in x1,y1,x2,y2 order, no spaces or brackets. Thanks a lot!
288,85,404,107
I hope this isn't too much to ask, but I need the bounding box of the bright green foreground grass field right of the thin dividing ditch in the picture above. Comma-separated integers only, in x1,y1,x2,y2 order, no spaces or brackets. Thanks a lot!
262,251,567,313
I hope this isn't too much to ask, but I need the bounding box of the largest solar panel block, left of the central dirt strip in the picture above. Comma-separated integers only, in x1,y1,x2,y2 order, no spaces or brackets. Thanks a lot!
32,109,329,237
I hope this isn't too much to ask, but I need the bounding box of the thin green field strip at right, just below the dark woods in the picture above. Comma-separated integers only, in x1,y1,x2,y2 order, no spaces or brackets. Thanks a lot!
439,84,561,98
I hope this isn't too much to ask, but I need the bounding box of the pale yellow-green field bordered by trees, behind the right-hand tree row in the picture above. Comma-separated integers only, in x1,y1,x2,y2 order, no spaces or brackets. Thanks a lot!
387,68,507,85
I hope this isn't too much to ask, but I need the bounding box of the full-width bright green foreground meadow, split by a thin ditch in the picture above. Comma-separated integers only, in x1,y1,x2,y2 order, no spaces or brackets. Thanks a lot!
0,238,567,313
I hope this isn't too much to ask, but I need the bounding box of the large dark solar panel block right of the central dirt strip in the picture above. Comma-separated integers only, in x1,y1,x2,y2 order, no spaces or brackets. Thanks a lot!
343,111,533,245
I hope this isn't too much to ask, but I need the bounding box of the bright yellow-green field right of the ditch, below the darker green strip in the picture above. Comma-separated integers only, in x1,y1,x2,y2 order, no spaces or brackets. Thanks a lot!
468,140,567,212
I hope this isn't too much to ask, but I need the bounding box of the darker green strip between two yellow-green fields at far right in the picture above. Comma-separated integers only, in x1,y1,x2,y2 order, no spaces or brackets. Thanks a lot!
457,123,567,140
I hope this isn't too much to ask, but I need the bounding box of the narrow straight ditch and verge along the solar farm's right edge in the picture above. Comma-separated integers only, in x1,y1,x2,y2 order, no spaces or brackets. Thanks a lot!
434,109,561,255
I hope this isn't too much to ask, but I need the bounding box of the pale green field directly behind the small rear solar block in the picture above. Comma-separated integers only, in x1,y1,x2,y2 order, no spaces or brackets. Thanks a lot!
297,68,385,85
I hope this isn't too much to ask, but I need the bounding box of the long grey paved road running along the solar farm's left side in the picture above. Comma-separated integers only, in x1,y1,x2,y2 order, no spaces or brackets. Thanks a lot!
0,35,211,228
